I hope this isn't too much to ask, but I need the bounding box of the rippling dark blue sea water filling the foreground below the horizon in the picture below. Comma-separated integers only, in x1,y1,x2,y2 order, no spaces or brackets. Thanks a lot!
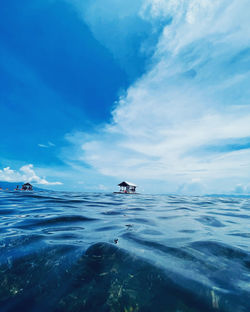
0,191,250,312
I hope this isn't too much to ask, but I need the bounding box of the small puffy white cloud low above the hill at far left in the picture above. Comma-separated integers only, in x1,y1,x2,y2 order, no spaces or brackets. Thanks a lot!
0,164,62,185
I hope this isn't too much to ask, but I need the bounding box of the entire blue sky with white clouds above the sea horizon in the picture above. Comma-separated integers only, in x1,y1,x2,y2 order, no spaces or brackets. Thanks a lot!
0,0,250,195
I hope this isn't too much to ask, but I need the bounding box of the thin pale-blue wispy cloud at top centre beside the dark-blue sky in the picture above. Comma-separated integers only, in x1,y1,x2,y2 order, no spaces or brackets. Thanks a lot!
65,0,164,79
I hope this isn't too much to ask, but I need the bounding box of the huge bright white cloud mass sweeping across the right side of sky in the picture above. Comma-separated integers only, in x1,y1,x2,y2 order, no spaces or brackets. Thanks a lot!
65,0,250,192
